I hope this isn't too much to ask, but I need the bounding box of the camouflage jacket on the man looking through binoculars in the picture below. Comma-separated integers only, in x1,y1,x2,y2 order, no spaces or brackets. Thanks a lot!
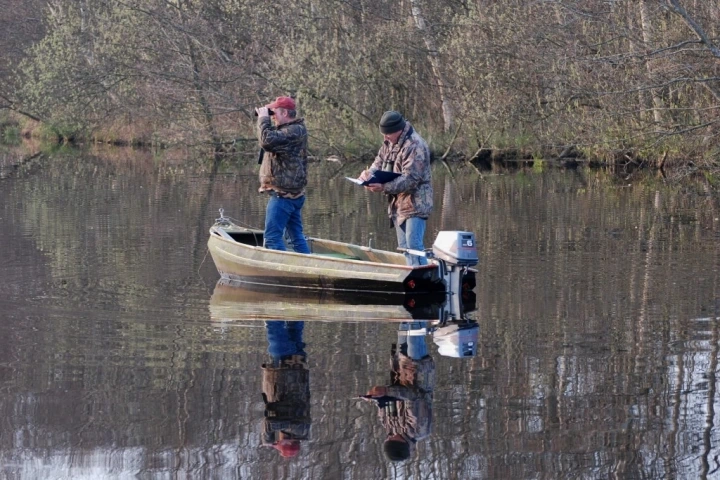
257,117,307,198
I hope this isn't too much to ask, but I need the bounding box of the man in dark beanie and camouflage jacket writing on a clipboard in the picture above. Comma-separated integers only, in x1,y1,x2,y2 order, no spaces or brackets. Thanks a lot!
350,111,433,265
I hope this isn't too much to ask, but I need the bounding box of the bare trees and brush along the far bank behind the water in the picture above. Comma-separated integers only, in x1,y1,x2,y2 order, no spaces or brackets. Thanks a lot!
0,0,720,170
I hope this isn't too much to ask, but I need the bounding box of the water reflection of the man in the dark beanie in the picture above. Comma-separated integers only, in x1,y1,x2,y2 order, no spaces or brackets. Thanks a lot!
363,322,435,461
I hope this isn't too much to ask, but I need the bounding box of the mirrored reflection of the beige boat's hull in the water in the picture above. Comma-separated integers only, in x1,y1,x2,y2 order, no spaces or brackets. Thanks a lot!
210,279,475,322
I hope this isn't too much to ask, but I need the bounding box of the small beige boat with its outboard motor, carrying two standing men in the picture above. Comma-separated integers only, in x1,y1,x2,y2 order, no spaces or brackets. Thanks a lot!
208,216,478,293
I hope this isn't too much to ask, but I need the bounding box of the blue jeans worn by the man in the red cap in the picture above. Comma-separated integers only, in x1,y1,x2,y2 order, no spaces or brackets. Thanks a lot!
265,194,310,253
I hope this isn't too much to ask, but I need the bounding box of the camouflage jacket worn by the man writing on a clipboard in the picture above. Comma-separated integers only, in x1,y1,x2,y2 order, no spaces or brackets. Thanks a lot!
370,122,433,229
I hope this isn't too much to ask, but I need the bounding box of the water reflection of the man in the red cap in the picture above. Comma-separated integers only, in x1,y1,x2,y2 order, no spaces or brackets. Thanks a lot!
262,321,311,457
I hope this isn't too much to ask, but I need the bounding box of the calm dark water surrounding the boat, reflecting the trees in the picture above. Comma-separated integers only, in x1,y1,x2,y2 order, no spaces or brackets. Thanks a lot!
0,150,720,479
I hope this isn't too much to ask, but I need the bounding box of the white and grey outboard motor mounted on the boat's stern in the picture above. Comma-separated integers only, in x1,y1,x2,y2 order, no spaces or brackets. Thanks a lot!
432,231,478,318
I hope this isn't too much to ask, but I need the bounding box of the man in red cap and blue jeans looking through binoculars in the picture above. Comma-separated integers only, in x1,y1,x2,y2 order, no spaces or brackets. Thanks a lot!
255,97,310,253
